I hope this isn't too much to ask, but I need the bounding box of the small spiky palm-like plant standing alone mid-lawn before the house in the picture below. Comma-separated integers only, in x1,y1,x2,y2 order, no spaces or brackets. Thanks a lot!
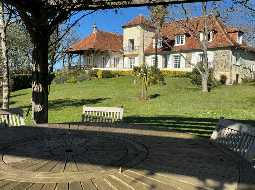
133,64,164,100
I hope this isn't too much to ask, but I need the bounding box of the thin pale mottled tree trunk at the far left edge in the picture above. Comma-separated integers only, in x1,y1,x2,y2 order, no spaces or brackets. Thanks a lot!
0,2,10,109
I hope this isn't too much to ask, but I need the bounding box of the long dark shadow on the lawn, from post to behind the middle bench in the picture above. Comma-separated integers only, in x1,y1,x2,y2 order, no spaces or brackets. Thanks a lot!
49,98,110,109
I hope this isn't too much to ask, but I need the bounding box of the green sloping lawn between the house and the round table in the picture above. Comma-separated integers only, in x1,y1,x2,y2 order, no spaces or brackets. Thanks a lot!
11,77,255,135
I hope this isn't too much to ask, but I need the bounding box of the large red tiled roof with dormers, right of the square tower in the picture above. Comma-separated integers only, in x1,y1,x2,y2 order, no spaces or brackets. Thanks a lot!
145,16,240,54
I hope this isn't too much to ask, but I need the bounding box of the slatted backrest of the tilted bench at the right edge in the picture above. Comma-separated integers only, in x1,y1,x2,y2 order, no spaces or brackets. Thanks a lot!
211,119,255,161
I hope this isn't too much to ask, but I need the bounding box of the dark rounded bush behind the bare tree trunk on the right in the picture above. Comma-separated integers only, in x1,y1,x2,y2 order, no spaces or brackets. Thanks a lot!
188,63,217,89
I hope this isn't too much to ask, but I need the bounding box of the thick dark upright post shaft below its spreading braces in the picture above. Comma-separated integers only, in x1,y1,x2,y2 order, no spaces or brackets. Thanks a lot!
32,30,49,124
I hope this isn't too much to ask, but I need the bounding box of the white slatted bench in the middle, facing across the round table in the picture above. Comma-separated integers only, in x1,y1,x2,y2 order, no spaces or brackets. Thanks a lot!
82,106,124,123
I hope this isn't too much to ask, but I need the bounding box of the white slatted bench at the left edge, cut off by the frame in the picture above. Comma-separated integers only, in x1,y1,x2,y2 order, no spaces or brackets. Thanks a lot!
0,108,25,127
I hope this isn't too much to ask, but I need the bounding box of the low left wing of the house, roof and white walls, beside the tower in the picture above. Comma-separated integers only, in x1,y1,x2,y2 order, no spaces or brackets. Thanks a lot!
68,25,123,69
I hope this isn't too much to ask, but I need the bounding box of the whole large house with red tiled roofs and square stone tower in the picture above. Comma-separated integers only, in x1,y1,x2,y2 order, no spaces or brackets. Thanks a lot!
68,15,255,84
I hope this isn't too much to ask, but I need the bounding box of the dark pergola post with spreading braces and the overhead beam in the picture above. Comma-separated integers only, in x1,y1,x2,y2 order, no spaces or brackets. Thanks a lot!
5,0,209,124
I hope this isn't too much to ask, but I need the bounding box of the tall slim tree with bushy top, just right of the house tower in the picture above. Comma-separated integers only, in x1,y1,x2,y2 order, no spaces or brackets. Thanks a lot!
149,5,168,68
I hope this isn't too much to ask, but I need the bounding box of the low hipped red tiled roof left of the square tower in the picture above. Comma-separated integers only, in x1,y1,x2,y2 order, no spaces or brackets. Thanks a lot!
67,30,123,53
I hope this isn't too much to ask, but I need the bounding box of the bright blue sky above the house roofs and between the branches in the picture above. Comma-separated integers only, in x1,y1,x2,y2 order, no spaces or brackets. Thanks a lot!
70,0,254,38
